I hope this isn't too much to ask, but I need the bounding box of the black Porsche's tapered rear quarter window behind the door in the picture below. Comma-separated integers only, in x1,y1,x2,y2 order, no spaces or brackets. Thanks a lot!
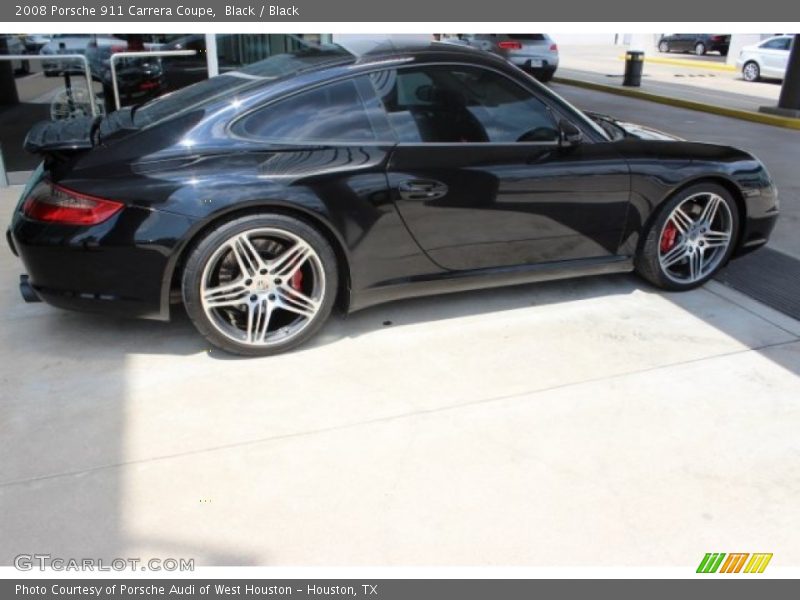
231,79,376,144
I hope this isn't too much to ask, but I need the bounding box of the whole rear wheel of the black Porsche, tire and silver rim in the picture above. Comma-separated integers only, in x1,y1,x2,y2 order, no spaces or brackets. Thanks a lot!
182,214,338,356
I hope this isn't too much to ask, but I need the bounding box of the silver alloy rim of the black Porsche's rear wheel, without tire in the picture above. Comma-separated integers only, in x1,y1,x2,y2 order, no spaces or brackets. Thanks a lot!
200,227,326,346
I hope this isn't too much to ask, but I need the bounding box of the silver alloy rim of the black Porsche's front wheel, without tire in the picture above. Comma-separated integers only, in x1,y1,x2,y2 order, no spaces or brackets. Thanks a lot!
658,193,733,284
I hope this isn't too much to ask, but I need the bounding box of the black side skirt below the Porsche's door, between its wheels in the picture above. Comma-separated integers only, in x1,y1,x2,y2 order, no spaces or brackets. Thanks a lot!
349,256,633,312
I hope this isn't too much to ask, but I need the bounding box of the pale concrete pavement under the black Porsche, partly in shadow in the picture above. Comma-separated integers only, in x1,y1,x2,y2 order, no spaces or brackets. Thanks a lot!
0,176,800,571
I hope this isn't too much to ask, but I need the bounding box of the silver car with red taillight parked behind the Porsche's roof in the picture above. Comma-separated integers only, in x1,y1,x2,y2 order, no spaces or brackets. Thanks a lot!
459,33,558,81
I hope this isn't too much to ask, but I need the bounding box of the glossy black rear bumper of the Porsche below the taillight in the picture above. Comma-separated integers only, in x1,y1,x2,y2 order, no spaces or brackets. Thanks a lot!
8,207,197,319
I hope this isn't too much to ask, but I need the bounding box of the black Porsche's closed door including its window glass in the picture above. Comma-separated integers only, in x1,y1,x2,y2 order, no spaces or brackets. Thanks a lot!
371,65,629,270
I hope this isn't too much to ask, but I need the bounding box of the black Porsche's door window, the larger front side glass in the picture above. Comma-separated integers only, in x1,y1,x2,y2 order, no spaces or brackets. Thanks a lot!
370,66,558,143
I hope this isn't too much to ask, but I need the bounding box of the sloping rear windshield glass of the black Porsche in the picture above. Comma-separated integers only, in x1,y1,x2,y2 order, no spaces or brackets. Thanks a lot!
133,44,354,127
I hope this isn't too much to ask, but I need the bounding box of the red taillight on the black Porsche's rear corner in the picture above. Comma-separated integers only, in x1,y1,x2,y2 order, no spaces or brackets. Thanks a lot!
22,182,123,225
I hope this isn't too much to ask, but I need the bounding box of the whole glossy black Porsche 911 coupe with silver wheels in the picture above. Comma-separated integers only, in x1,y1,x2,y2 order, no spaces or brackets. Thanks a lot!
9,44,778,355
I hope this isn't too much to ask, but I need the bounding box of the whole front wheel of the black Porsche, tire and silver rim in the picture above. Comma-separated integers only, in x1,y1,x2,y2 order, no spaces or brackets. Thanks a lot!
636,183,739,290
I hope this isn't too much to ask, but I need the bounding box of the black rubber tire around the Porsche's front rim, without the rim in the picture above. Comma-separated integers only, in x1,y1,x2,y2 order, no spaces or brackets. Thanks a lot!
635,182,739,291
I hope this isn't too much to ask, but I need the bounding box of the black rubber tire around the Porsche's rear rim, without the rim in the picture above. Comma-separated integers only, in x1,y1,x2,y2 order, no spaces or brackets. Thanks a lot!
181,213,339,356
